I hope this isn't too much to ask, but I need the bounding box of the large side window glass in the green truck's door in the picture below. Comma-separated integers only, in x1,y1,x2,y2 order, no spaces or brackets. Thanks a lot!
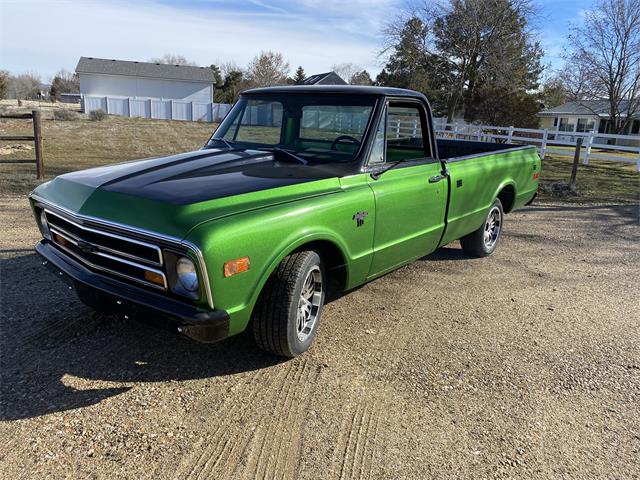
385,103,431,162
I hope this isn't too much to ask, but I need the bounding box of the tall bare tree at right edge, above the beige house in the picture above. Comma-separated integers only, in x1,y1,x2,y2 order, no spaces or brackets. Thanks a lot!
566,0,640,134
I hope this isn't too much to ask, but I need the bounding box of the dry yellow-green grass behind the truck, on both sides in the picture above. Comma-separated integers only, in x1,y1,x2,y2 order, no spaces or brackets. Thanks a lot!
0,117,640,203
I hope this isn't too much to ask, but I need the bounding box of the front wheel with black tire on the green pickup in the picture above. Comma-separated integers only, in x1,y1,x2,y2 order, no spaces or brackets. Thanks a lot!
252,251,326,358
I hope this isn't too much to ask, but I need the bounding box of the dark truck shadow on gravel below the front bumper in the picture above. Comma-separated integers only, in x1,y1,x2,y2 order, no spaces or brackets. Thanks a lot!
0,252,283,420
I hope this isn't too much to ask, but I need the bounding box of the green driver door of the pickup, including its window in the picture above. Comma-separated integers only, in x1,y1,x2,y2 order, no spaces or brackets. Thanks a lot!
368,100,447,278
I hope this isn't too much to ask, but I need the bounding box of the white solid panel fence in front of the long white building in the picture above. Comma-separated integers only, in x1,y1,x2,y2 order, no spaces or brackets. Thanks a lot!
82,95,231,122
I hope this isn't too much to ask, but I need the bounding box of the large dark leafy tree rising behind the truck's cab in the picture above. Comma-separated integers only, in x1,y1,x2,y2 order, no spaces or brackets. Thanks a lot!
376,0,543,124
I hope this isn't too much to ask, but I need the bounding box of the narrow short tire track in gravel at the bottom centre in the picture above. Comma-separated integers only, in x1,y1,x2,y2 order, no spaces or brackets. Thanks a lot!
332,401,381,480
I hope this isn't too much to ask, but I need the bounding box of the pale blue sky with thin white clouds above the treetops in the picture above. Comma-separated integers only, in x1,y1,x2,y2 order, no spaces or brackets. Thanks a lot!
0,0,592,81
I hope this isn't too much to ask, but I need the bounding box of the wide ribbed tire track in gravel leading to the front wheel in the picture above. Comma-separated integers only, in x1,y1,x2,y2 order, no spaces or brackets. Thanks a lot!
174,360,317,480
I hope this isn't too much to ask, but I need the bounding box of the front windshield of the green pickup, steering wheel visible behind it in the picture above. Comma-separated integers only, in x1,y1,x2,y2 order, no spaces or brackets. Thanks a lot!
209,93,376,163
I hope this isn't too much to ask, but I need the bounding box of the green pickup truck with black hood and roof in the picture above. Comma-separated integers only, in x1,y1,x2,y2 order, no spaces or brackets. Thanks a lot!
30,86,541,357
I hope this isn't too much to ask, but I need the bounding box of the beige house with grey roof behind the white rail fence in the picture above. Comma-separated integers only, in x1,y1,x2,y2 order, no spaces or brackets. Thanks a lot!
538,100,640,146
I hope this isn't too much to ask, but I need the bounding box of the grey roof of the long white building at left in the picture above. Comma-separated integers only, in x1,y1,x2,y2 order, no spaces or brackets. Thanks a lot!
76,57,213,83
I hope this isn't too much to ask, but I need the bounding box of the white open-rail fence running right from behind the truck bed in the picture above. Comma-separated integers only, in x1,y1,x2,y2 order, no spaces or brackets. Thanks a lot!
435,123,640,172
